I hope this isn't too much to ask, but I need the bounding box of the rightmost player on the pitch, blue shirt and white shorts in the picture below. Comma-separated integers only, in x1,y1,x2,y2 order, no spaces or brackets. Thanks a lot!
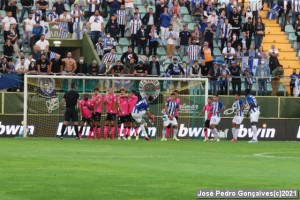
245,89,260,143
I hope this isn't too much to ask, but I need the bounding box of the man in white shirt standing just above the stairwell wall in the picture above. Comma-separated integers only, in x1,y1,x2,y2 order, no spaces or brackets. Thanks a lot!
88,10,104,45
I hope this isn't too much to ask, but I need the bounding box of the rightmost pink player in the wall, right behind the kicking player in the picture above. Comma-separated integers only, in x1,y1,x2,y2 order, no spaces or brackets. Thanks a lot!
127,90,139,140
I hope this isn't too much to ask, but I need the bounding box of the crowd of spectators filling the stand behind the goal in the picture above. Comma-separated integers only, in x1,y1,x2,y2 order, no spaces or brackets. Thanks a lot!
0,0,300,95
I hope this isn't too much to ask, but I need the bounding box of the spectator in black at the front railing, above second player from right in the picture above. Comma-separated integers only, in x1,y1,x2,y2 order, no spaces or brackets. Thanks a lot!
229,60,242,94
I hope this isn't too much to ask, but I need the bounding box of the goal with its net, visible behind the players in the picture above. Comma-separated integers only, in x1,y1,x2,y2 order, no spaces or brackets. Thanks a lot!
23,75,208,138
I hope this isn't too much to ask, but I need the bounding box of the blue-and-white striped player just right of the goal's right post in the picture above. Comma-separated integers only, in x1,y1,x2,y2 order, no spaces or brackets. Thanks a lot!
209,94,225,142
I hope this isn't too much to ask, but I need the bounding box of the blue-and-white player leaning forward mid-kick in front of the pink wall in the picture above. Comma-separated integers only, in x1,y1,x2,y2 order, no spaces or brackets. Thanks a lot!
131,96,155,141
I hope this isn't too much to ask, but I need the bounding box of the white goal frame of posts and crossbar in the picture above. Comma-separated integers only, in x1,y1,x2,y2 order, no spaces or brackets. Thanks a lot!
23,74,209,137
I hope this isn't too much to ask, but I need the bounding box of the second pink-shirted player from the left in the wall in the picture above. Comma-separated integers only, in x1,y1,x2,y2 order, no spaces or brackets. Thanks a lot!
89,88,103,140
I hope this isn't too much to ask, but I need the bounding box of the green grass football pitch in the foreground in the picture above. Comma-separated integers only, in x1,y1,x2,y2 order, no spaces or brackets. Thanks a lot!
0,138,300,200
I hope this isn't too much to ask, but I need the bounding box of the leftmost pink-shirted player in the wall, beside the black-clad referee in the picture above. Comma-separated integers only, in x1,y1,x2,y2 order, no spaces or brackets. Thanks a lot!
79,94,94,139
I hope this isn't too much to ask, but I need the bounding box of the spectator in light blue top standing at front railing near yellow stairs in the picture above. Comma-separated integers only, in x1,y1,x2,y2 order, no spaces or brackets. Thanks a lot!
255,58,270,96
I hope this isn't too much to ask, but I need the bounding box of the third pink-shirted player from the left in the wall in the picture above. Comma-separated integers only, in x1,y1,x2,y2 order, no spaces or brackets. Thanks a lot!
104,88,117,139
